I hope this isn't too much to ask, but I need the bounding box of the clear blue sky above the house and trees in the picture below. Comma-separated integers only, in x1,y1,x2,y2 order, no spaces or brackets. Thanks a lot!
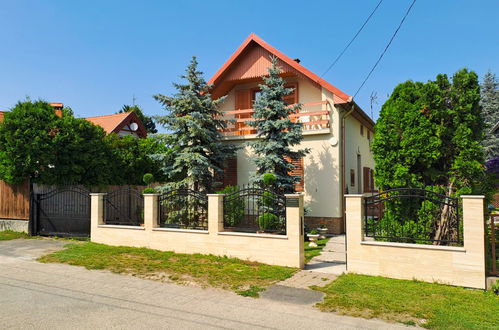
0,0,499,125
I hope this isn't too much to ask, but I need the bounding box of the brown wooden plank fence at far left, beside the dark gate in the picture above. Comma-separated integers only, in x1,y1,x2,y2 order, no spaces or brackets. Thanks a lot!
0,181,29,220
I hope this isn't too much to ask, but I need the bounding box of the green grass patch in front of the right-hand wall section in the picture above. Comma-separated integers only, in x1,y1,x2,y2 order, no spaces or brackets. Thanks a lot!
314,274,499,329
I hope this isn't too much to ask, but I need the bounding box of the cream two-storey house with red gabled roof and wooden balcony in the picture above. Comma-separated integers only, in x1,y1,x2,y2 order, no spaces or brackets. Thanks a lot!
209,34,374,233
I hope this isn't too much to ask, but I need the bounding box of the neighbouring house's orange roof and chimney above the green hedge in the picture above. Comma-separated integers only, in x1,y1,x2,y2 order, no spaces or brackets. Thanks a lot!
0,102,147,139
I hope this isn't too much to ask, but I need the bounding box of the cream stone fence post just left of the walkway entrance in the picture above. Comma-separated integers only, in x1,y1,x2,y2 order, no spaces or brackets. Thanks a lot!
285,194,305,268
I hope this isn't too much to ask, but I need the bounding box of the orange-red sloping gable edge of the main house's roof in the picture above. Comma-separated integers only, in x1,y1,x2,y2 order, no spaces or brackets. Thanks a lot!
208,33,352,104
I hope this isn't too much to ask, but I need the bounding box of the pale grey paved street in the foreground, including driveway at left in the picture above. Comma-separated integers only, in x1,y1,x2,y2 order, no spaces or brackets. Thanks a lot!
0,240,405,330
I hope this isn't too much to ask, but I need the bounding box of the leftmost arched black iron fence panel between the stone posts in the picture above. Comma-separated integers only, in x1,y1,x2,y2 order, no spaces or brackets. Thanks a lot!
104,188,144,226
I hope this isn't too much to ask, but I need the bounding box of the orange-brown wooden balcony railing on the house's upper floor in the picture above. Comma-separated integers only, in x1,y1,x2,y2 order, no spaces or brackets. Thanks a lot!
223,101,331,137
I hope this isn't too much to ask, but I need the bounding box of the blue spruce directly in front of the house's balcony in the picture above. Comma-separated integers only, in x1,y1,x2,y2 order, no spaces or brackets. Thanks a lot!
248,57,308,193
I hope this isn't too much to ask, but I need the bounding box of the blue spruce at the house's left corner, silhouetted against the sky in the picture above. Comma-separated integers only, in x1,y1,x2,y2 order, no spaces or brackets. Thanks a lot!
154,57,235,192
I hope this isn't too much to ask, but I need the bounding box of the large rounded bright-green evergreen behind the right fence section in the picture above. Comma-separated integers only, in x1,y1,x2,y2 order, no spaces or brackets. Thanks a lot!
372,69,490,240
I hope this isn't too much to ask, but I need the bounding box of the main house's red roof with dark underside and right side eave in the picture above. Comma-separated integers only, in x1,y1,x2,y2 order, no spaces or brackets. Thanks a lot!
208,33,374,129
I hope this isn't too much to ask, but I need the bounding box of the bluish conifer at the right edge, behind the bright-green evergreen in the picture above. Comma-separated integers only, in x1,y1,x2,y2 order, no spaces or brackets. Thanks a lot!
480,71,499,159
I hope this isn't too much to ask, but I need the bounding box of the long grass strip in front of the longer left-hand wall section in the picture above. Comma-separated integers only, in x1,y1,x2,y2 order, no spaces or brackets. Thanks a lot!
38,242,298,297
